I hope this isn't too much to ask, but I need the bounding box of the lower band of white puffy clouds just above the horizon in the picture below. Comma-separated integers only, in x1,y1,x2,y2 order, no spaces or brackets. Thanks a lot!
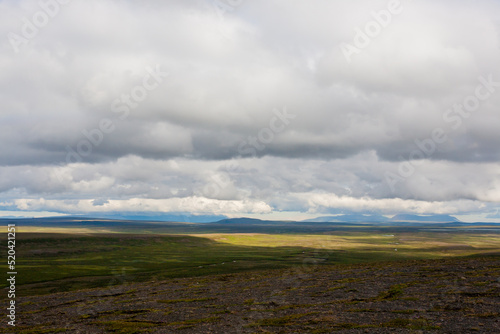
0,152,500,214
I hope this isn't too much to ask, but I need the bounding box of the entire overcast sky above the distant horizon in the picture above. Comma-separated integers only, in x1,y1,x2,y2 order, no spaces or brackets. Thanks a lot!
0,0,500,221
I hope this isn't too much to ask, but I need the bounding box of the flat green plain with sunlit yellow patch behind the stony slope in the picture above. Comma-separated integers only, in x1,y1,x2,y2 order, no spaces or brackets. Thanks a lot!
2,227,500,298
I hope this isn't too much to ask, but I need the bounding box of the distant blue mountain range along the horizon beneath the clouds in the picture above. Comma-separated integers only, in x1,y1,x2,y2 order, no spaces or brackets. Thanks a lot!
0,214,500,234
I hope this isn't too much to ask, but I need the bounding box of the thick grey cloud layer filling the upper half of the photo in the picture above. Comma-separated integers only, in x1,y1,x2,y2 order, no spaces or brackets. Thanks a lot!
3,2,498,164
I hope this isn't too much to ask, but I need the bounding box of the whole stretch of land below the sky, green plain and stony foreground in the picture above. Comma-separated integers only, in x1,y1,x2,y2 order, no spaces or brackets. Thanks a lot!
1,222,500,333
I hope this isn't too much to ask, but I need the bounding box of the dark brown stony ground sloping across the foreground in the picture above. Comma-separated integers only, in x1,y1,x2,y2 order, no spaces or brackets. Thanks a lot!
2,256,500,333
